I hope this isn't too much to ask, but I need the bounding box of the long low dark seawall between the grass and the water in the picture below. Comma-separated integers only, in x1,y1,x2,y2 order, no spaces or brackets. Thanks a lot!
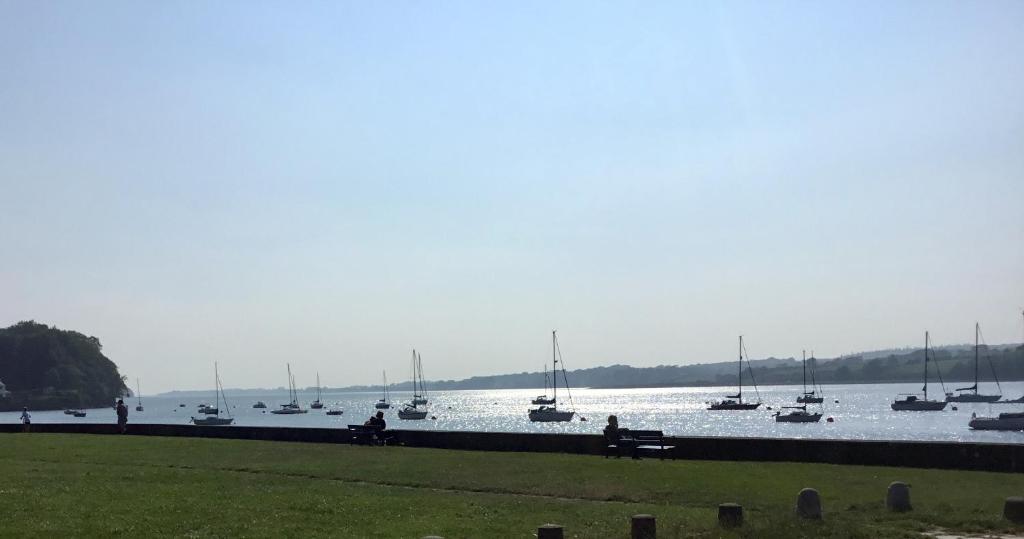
0,423,1024,472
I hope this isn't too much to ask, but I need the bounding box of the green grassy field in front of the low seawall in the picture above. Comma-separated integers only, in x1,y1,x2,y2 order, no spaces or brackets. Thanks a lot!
0,433,1024,539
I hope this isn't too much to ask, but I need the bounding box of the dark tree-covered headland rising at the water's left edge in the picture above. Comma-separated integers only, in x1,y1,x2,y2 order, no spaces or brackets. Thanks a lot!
0,321,128,411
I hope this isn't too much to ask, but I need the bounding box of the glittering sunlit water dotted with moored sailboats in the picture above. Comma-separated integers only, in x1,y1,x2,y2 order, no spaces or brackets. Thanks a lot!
8,382,1024,444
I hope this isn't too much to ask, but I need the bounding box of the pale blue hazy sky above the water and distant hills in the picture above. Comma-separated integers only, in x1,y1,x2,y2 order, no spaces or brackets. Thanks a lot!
0,0,1024,392
